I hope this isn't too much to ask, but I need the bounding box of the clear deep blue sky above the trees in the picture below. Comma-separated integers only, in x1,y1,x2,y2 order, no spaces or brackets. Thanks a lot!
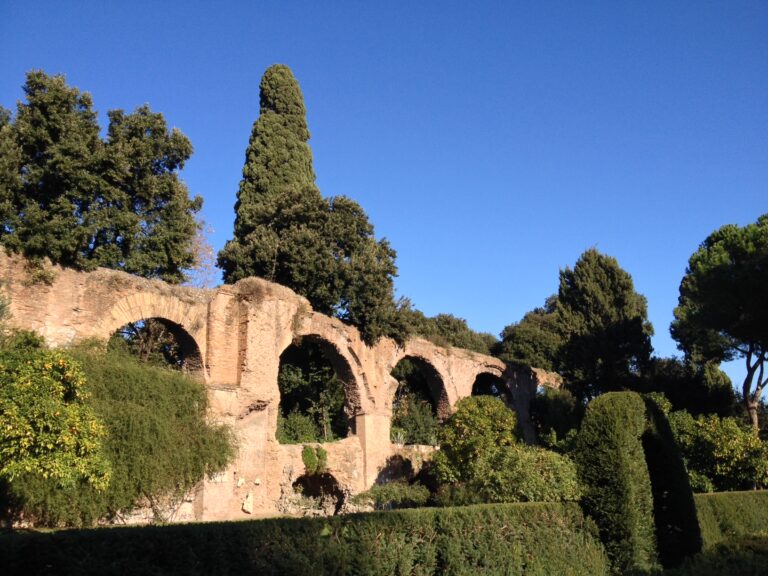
0,0,768,388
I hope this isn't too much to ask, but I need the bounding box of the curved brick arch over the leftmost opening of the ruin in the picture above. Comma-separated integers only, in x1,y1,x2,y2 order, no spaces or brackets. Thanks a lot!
97,293,208,382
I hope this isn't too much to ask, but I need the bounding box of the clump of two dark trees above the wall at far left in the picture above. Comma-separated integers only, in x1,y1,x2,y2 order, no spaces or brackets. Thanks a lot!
0,71,202,283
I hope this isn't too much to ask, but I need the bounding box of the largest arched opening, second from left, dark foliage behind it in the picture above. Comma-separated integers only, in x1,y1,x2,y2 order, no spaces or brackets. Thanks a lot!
275,336,359,444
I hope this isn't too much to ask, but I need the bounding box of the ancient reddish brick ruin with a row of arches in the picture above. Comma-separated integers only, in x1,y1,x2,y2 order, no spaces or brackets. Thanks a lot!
0,253,558,521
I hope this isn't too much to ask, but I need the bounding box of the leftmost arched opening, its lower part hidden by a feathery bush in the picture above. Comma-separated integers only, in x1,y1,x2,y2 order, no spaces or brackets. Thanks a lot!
107,318,204,379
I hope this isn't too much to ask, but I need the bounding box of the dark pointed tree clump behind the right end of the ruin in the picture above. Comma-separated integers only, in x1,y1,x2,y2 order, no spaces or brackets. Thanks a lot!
497,248,653,400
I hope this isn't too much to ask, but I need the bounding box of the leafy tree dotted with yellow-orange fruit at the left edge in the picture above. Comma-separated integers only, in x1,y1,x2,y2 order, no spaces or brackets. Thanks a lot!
0,334,115,518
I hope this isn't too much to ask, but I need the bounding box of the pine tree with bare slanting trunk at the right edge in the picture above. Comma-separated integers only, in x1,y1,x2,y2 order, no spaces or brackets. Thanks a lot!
671,214,768,432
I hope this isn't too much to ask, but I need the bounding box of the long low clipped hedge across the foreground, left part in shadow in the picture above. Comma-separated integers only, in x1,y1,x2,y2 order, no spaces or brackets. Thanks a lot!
0,503,608,576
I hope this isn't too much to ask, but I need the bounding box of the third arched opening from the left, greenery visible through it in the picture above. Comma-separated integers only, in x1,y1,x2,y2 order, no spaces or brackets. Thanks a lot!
390,356,450,446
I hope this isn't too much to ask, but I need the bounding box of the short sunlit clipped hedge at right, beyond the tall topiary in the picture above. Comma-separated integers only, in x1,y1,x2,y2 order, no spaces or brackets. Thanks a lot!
694,490,768,549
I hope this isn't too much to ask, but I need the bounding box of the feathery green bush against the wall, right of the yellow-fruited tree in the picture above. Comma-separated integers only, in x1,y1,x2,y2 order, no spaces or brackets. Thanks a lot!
6,346,234,526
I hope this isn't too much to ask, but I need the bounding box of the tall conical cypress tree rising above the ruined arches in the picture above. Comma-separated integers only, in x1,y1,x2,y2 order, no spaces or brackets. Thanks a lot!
219,65,338,313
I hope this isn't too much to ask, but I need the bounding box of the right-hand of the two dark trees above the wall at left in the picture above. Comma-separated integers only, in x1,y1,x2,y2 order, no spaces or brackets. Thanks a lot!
97,105,203,284
